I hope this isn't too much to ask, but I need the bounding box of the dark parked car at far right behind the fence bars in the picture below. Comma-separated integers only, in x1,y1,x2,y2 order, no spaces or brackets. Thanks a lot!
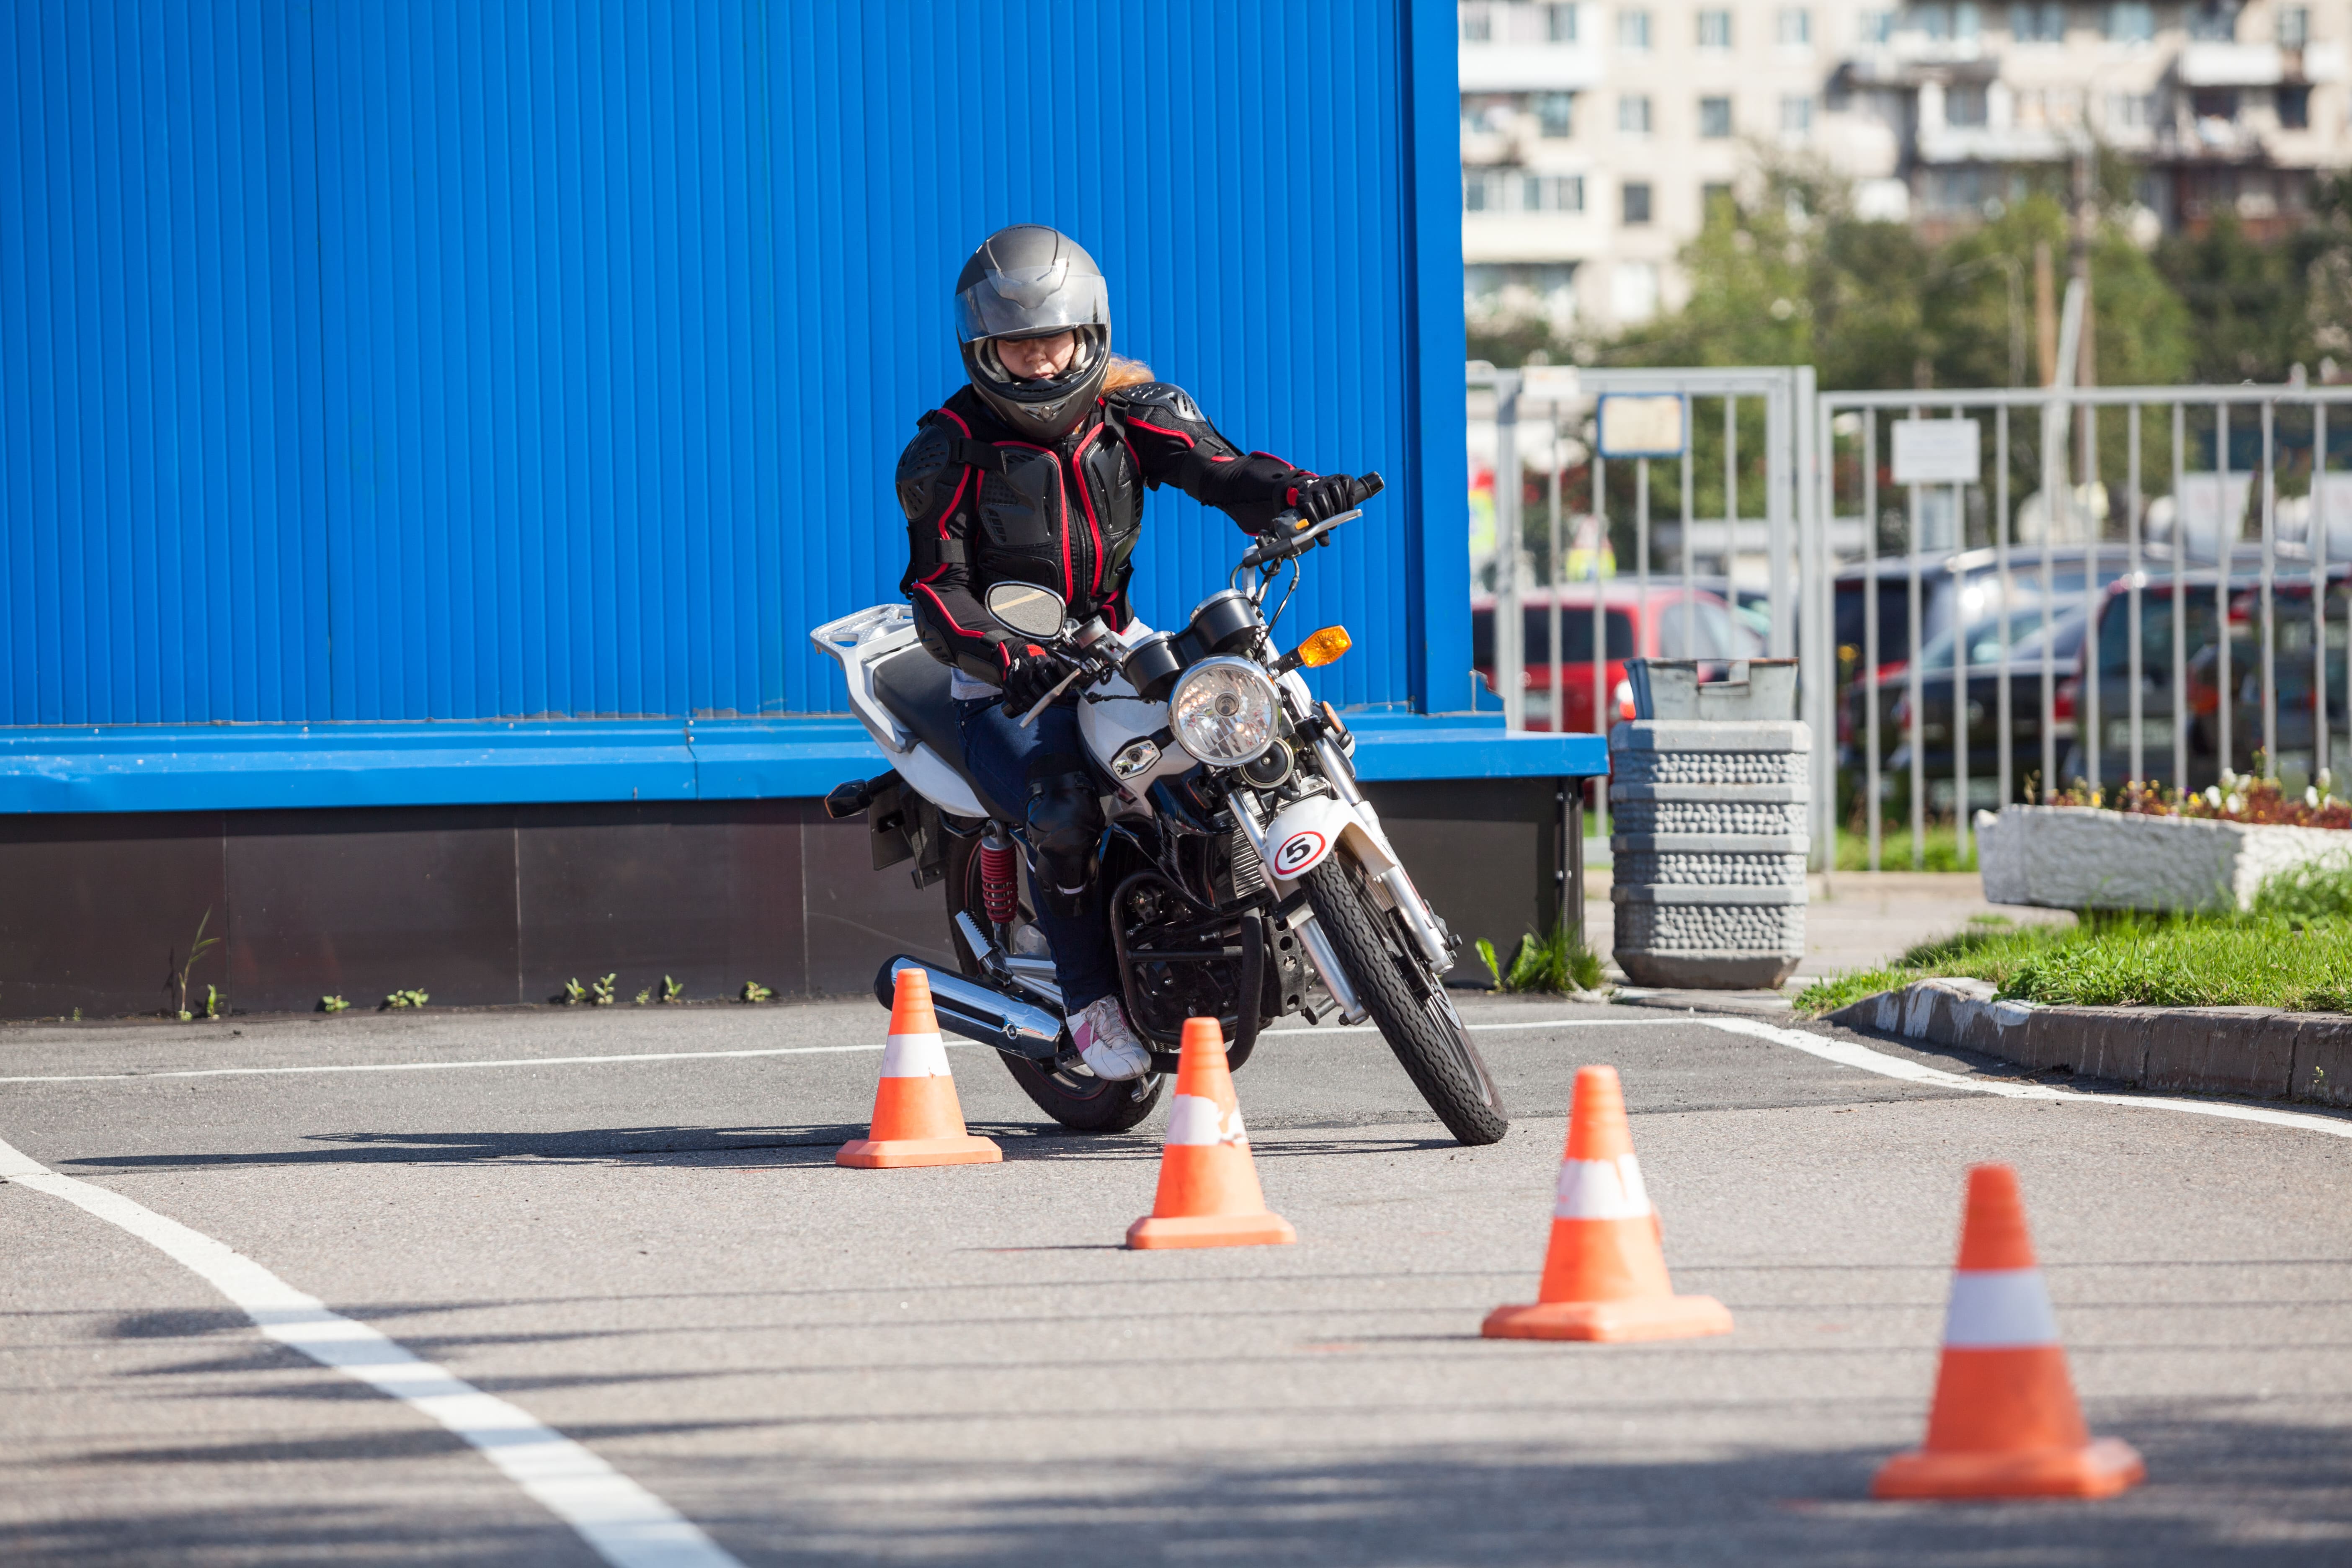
2058,571,2352,790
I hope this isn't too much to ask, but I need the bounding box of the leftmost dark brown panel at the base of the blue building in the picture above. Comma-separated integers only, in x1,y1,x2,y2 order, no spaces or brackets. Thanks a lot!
0,811,228,1018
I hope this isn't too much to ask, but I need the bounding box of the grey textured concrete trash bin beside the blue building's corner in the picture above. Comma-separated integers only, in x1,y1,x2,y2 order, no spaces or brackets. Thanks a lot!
1609,658,1813,990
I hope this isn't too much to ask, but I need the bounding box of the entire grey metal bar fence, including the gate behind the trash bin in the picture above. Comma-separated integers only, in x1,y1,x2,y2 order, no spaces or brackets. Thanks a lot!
1467,359,2352,893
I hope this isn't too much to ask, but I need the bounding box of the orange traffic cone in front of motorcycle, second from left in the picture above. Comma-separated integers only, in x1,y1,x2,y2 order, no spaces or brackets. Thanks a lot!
1127,1018,1298,1246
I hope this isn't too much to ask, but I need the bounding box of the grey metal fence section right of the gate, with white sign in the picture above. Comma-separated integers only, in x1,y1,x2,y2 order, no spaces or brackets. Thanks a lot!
1806,386,2352,870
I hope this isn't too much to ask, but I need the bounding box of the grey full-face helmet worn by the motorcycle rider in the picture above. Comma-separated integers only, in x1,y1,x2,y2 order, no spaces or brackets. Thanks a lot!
955,223,1110,442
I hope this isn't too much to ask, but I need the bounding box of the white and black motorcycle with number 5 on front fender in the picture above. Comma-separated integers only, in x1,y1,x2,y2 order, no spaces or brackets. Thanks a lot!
809,475,1510,1145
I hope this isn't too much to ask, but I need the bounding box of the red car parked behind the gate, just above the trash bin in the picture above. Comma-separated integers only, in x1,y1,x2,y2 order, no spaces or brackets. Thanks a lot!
1470,578,1764,733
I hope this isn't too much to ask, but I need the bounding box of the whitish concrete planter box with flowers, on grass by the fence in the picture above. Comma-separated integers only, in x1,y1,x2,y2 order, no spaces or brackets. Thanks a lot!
1975,806,2352,910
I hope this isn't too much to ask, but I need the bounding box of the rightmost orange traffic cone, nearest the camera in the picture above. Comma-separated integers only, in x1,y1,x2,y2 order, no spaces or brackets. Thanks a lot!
1870,1166,2147,1498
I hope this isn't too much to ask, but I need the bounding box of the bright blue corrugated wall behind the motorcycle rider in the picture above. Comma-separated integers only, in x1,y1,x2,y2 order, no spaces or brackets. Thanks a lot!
0,0,1467,743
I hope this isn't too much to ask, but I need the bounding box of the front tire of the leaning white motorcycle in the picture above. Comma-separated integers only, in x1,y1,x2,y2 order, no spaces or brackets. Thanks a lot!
1305,856,1510,1145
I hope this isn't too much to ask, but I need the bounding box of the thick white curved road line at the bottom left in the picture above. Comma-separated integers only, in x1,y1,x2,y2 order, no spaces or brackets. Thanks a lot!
0,1142,743,1568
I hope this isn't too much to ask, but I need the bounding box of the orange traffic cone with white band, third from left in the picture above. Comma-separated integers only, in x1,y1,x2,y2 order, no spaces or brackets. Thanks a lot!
1479,1067,1731,1340
